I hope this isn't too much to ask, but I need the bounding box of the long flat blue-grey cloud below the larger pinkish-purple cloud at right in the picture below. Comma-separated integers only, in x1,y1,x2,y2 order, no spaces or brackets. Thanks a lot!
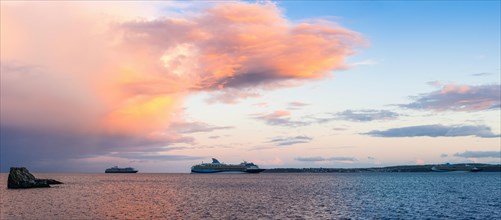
363,124,501,138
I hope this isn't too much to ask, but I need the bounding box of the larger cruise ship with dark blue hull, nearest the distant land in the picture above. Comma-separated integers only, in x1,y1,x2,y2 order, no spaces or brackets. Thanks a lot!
191,158,265,173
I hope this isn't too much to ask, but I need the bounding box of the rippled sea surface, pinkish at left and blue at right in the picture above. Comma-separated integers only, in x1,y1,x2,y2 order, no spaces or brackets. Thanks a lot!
0,173,501,219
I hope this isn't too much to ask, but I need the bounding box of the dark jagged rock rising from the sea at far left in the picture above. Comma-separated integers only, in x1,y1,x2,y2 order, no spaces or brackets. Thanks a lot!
7,167,63,189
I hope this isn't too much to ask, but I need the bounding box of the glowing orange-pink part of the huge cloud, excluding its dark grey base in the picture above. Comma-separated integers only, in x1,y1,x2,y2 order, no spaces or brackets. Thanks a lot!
1,2,364,135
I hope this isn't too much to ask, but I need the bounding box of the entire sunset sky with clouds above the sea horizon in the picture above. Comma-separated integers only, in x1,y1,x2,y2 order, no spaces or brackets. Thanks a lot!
0,1,501,173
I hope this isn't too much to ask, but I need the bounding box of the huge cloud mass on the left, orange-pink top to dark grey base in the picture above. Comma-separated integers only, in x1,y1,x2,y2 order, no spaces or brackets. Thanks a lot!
0,1,365,172
